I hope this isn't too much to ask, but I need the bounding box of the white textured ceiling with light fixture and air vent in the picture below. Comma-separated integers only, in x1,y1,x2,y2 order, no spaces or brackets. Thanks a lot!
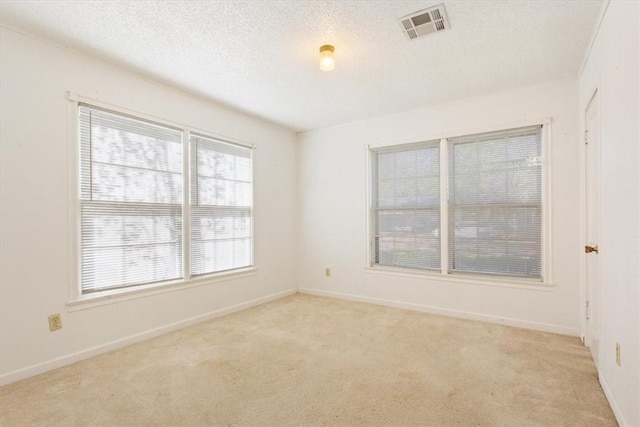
0,0,602,130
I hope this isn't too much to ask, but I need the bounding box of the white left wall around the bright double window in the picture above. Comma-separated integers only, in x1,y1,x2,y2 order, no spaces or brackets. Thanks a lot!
0,28,297,382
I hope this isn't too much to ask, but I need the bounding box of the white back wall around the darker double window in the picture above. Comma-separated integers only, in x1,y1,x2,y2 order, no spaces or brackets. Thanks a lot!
298,81,580,335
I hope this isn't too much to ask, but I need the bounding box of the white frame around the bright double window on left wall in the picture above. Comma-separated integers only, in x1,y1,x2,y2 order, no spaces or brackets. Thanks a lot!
66,92,258,311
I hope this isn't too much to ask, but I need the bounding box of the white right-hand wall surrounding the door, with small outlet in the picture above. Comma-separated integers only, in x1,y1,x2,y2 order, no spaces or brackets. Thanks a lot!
579,1,640,426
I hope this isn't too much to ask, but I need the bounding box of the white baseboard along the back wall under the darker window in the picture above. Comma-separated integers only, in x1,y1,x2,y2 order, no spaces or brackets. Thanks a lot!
298,288,580,337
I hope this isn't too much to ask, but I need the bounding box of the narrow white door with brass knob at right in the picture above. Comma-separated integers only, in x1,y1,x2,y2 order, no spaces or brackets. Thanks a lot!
584,91,601,368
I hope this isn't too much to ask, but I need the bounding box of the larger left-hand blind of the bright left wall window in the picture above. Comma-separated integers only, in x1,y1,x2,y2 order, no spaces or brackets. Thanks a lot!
79,105,183,293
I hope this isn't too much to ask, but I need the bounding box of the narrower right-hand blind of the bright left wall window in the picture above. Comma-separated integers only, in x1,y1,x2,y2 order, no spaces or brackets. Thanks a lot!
190,134,253,276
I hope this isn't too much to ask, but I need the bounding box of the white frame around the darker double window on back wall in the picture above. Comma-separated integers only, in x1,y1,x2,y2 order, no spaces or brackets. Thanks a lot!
364,117,555,290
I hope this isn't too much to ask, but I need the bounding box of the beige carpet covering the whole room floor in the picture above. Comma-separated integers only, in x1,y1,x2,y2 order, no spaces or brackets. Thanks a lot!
0,295,616,427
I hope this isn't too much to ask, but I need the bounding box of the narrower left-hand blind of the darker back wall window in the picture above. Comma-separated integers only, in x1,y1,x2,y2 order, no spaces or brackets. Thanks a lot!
372,141,440,269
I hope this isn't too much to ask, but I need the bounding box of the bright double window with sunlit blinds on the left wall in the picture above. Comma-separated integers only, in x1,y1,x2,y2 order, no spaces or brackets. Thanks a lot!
79,104,252,294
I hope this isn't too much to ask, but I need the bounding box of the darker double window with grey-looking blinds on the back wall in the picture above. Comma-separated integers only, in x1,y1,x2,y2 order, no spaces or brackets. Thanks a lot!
371,126,543,279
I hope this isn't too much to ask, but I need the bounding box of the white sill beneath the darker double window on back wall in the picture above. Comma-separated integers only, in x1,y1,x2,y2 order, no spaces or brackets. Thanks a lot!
365,266,556,292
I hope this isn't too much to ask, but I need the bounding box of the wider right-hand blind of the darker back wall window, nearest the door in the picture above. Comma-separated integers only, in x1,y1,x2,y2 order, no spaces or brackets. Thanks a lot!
448,126,542,277
